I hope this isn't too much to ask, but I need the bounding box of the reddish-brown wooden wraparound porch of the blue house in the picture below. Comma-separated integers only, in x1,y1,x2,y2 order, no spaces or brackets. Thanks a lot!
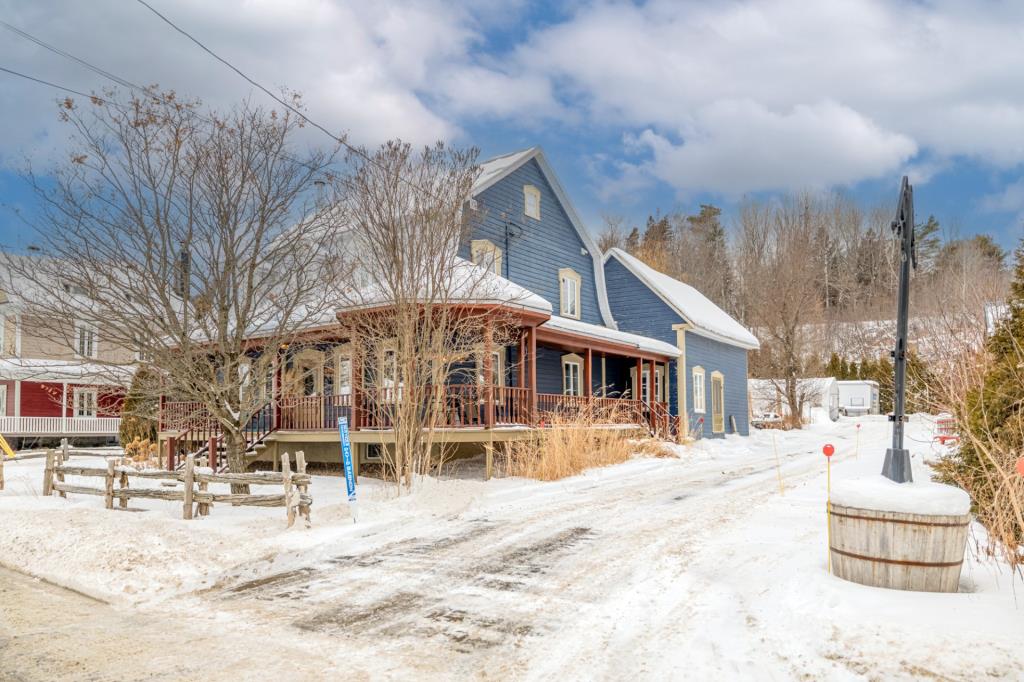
160,318,678,466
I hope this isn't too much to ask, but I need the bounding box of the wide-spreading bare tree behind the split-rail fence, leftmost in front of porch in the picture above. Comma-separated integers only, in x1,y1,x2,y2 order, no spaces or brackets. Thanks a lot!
5,89,339,483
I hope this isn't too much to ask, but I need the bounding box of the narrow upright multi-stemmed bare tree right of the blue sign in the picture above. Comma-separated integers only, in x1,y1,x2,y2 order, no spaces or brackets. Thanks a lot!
341,141,525,488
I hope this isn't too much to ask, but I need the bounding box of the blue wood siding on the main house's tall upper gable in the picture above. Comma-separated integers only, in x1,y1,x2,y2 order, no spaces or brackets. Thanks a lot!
459,159,604,327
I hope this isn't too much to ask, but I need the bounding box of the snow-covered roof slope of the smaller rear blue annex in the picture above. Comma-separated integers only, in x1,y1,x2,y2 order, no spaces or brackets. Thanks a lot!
604,249,761,350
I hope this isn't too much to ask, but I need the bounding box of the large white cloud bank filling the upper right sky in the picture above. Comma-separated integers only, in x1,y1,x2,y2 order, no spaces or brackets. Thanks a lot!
493,0,1024,194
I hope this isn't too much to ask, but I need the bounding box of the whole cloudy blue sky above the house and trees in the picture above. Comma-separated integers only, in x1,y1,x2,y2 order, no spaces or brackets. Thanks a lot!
0,0,1024,247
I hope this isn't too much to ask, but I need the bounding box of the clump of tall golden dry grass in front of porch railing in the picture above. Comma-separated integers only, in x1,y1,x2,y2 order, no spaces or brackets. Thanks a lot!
503,401,675,480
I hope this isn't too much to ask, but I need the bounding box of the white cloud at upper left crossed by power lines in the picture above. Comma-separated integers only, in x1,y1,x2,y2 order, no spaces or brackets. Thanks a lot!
0,0,477,164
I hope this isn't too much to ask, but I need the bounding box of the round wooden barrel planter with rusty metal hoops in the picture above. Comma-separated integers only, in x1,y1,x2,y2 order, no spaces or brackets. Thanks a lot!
828,503,971,592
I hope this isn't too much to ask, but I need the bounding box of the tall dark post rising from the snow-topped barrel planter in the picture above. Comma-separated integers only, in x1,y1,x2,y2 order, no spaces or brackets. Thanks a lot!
882,175,918,483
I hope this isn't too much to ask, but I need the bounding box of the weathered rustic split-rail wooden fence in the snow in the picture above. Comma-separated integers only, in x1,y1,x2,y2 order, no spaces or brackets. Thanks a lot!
43,450,313,527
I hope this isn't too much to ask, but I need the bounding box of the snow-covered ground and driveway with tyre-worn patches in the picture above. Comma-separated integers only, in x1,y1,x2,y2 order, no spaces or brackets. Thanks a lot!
0,417,1024,680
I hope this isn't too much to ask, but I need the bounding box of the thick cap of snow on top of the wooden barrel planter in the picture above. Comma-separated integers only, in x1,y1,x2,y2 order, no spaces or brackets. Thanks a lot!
831,475,971,516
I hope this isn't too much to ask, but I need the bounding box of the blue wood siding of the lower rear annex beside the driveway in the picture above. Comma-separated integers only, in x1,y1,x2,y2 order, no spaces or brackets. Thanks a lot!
604,257,750,437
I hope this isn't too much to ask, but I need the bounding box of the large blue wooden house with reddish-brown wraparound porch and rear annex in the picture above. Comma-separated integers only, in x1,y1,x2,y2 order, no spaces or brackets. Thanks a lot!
160,147,758,471
